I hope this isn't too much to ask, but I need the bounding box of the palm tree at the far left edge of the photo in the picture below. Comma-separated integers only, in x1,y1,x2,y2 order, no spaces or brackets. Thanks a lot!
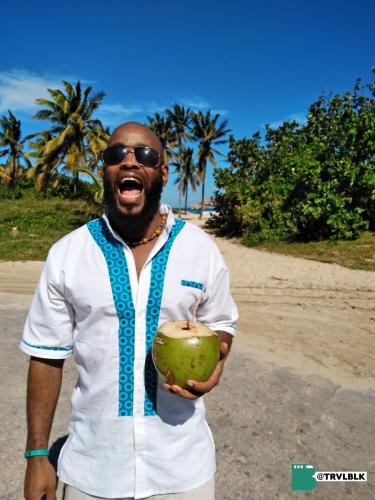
0,110,31,189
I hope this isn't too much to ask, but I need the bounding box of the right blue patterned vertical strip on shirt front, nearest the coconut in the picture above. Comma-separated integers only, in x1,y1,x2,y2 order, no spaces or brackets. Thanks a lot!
144,219,185,415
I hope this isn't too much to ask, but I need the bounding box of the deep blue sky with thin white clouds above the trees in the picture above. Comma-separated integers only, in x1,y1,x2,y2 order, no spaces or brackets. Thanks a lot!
0,0,375,206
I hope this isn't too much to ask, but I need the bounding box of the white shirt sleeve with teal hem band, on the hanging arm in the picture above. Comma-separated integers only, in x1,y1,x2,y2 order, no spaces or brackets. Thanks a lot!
20,252,74,359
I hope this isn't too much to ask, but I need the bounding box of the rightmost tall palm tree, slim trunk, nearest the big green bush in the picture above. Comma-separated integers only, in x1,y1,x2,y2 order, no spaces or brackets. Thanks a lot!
191,110,230,218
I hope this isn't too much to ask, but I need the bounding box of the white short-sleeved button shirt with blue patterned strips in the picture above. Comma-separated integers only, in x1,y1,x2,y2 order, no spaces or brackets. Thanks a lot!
20,205,238,498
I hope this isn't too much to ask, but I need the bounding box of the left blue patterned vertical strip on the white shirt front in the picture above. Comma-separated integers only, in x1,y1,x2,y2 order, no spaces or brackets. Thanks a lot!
87,219,135,417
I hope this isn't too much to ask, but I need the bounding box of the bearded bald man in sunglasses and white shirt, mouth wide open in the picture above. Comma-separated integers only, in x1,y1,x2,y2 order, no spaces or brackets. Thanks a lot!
20,122,237,500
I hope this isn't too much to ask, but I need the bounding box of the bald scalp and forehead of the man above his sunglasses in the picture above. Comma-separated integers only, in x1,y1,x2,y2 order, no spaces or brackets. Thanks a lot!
108,122,164,160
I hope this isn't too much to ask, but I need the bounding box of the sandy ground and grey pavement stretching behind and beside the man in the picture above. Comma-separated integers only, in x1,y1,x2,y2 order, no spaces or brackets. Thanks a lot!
0,215,375,500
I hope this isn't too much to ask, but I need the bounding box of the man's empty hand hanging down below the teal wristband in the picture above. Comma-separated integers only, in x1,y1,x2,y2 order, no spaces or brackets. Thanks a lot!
24,457,57,500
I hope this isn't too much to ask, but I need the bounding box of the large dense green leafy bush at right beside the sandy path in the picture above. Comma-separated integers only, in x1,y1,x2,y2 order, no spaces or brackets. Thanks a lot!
210,73,375,244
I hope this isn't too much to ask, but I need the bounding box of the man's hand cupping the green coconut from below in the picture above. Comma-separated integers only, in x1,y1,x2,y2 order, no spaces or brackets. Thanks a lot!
164,331,233,400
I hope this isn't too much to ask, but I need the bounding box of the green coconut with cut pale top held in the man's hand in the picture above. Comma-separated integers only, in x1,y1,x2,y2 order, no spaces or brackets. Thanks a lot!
152,320,220,387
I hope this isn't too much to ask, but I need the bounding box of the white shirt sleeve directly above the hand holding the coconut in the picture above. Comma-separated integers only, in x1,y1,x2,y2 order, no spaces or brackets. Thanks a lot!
197,250,238,335
